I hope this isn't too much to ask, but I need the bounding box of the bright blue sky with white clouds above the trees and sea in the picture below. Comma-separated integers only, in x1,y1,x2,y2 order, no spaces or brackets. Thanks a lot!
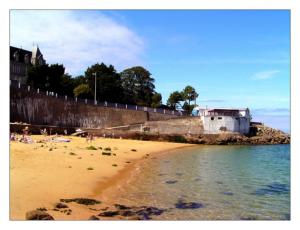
11,10,290,131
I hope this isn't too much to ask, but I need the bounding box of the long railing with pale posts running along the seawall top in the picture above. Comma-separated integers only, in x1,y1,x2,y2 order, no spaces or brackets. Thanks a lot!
10,80,189,116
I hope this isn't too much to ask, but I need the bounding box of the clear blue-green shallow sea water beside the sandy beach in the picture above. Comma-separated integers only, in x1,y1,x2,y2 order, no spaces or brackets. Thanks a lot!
108,145,290,220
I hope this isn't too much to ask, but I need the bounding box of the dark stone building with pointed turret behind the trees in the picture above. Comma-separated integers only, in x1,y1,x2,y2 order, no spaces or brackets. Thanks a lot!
10,45,46,84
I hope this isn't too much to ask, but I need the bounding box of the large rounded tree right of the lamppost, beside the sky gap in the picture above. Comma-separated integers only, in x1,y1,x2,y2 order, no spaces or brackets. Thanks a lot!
121,66,155,106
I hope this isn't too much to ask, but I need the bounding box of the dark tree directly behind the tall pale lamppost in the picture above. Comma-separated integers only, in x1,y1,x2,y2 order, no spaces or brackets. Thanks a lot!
85,63,123,102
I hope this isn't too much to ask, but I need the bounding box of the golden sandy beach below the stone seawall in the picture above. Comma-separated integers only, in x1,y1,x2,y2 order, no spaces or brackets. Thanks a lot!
10,136,193,220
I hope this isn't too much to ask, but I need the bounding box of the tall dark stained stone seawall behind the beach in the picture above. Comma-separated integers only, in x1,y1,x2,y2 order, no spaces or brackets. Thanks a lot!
10,87,177,128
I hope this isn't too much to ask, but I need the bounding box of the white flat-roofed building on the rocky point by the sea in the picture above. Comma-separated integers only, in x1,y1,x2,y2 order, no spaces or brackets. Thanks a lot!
193,107,251,134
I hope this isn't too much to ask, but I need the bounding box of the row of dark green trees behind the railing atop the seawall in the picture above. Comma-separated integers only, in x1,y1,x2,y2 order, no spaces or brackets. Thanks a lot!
27,60,198,112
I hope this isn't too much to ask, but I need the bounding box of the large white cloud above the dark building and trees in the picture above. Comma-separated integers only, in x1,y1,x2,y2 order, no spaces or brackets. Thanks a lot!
10,10,144,75
